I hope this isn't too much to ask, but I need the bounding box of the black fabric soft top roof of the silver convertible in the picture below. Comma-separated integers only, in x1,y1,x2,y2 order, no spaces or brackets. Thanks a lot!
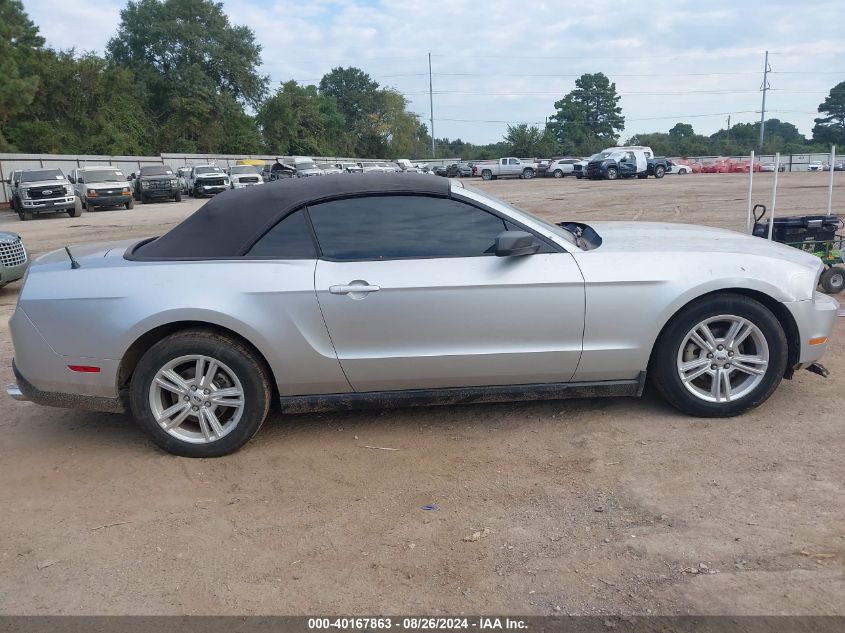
130,173,449,259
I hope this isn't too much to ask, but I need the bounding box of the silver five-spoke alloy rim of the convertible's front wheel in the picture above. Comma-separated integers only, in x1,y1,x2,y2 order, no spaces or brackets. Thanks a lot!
677,314,769,403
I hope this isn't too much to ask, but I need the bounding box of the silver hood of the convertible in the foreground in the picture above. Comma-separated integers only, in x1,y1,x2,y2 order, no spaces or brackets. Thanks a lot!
590,222,820,270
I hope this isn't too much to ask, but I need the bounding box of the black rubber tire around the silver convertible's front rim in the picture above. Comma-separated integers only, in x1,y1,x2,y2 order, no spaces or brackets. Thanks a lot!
649,293,788,418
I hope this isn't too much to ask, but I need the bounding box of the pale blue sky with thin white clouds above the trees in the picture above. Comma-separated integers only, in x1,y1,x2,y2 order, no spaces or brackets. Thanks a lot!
19,0,845,143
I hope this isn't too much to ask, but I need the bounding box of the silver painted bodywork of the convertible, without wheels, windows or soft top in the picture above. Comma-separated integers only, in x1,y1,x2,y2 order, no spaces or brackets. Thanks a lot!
6,182,838,412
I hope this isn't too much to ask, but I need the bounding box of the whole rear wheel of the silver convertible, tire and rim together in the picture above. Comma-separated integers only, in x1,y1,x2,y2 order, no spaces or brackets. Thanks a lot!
130,330,272,457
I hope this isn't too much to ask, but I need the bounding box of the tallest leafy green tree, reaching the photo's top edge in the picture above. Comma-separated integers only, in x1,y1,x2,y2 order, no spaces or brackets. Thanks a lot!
107,0,268,153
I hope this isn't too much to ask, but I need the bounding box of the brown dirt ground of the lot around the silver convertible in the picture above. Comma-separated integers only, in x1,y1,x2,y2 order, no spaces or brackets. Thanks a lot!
0,174,845,615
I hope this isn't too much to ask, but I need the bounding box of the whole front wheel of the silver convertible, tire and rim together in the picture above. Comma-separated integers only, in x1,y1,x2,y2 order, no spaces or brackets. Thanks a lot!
650,294,787,418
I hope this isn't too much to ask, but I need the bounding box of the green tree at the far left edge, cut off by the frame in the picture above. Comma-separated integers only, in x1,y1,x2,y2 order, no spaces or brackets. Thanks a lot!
0,0,44,151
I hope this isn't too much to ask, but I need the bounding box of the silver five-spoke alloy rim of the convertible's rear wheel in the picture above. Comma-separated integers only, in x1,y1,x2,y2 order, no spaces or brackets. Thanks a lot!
149,354,245,444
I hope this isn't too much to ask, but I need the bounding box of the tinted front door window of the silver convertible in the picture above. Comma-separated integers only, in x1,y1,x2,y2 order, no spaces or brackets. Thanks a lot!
308,196,505,261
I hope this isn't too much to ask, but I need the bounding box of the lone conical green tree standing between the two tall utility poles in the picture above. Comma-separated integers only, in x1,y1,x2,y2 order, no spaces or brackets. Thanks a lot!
549,73,625,155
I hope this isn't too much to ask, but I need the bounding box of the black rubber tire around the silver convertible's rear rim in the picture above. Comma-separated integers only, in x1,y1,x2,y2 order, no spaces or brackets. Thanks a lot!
129,330,273,457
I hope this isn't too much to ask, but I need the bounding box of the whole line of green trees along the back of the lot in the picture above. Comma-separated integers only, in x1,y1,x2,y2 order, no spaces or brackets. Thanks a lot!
0,0,845,160
